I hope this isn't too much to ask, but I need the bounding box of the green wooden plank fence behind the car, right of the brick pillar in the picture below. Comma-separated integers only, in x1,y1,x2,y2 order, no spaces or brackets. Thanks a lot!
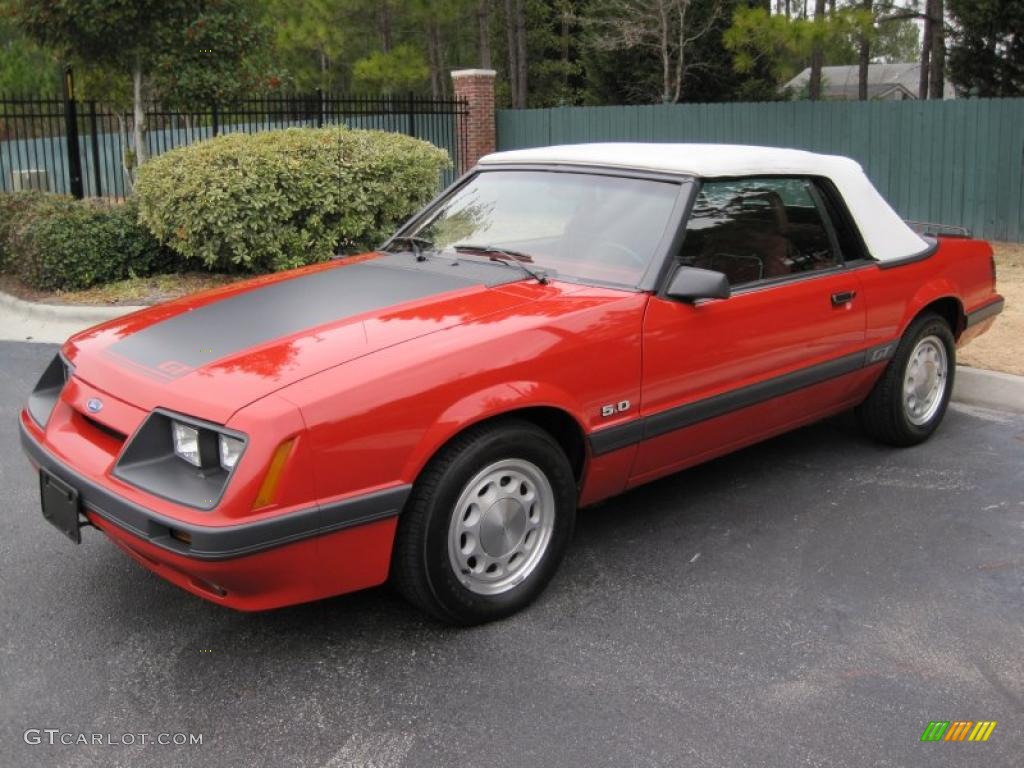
498,98,1024,242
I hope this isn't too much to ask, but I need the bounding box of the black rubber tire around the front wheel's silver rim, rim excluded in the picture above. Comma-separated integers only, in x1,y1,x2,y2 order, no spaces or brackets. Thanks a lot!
391,419,577,626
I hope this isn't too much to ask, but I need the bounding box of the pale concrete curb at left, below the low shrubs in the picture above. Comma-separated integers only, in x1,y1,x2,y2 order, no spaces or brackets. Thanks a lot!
0,292,145,344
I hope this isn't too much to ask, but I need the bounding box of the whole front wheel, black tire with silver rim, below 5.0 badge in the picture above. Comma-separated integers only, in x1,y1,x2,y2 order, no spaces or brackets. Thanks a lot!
392,421,575,625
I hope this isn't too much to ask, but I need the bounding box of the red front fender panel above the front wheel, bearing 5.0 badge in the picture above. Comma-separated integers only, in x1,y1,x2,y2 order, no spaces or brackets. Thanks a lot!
282,288,647,501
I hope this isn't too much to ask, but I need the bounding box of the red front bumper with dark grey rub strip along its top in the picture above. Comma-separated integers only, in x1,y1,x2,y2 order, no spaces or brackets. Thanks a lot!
20,415,411,610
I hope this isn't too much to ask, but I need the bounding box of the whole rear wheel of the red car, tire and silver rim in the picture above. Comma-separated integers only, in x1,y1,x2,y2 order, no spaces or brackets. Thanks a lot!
857,313,956,445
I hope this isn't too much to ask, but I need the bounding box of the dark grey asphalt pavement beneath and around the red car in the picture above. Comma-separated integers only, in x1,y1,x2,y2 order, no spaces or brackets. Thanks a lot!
0,343,1024,768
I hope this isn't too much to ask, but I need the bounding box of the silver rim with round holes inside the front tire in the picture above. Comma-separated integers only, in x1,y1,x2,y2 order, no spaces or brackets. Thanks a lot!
449,459,555,595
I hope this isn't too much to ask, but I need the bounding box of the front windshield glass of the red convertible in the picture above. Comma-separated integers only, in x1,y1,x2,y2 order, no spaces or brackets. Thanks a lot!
406,170,679,287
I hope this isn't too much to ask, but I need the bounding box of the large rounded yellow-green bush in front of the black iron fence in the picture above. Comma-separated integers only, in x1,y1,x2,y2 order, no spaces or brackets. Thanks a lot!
135,127,449,271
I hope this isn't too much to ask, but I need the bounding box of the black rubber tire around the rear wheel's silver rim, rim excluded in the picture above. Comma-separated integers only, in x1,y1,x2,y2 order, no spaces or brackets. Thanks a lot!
856,312,956,447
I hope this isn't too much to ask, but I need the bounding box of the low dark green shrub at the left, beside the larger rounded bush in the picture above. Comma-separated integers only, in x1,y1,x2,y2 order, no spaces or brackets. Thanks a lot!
7,195,179,291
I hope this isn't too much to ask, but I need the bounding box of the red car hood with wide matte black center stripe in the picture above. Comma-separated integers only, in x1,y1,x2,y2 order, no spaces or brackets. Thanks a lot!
63,254,558,423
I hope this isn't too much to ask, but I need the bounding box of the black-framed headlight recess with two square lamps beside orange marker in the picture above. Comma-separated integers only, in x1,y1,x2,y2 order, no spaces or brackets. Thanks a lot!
114,409,246,509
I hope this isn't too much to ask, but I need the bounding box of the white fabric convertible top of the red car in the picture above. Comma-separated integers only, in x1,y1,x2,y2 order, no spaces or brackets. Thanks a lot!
479,142,931,261
